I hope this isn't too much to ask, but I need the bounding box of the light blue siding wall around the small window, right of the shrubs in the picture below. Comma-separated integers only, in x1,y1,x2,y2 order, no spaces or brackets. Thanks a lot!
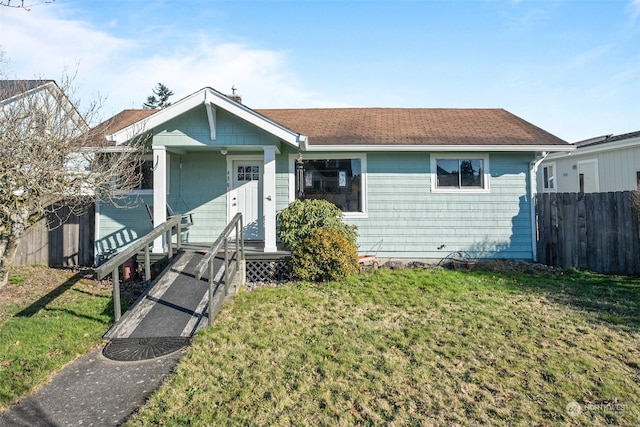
349,153,532,259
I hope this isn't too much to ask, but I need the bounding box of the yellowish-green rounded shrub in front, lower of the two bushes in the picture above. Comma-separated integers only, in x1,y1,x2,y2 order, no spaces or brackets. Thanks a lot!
291,227,358,282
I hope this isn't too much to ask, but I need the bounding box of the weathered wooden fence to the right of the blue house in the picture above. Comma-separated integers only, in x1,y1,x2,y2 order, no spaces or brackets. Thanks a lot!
536,191,640,274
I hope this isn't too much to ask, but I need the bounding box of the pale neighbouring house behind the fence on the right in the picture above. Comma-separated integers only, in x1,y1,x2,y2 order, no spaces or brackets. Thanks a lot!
538,131,640,193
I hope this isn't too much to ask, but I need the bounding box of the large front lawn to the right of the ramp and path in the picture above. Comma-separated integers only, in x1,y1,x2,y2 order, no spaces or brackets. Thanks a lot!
128,270,640,426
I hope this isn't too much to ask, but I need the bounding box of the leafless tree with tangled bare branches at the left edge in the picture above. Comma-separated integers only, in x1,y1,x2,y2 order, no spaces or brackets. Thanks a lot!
0,73,145,287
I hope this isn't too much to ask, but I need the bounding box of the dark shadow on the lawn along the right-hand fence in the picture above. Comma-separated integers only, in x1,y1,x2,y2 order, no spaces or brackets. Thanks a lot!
470,271,640,330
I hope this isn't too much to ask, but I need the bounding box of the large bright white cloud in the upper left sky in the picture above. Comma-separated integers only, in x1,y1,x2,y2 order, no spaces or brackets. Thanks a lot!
0,4,330,122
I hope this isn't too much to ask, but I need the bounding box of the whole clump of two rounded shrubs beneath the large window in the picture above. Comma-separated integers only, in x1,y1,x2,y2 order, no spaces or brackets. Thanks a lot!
278,200,358,281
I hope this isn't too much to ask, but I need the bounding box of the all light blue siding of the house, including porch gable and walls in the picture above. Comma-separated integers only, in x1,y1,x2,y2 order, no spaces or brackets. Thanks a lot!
96,106,533,259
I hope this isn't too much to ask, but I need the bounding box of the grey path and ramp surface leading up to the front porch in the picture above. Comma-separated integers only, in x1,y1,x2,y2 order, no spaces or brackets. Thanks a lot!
0,251,230,427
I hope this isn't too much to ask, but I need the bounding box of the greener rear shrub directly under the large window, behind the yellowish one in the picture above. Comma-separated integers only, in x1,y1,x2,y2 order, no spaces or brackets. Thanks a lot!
278,200,358,251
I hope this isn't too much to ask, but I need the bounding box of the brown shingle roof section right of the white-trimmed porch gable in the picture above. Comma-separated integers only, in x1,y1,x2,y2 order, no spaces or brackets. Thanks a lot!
256,108,568,146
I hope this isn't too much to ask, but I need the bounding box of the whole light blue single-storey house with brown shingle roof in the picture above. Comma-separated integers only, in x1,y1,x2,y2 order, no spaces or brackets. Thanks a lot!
96,88,573,262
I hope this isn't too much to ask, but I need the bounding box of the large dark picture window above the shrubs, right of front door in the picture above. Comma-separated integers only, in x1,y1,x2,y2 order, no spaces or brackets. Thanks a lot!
293,155,366,216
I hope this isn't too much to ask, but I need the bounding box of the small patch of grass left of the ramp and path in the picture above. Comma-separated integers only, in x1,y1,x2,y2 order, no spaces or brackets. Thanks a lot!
0,266,113,410
